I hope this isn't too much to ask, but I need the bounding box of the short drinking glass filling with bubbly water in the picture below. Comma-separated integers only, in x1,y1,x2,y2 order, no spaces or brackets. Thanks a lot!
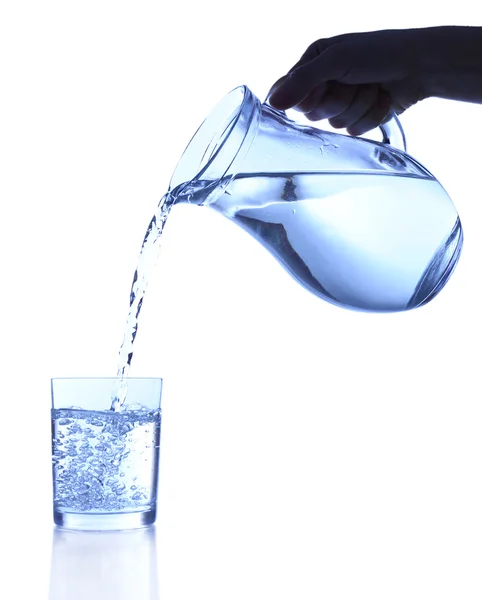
51,377,162,530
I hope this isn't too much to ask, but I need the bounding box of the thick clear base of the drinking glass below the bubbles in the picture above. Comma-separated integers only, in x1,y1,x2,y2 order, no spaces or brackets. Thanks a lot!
54,509,156,531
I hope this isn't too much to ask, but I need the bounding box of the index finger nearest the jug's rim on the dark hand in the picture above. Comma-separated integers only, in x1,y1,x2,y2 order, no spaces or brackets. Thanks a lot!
270,44,349,110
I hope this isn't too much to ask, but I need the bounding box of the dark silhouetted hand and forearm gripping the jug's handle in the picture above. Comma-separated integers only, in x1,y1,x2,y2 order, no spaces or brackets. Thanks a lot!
269,27,482,135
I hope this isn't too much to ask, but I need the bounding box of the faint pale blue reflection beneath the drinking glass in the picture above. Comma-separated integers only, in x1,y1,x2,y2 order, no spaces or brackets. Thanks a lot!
49,527,159,600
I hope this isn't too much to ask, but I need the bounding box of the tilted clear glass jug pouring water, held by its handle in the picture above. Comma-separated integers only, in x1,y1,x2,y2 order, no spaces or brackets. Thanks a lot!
169,86,463,312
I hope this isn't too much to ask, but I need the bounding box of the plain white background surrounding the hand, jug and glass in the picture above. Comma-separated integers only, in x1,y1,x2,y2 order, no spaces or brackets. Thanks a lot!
0,0,482,600
